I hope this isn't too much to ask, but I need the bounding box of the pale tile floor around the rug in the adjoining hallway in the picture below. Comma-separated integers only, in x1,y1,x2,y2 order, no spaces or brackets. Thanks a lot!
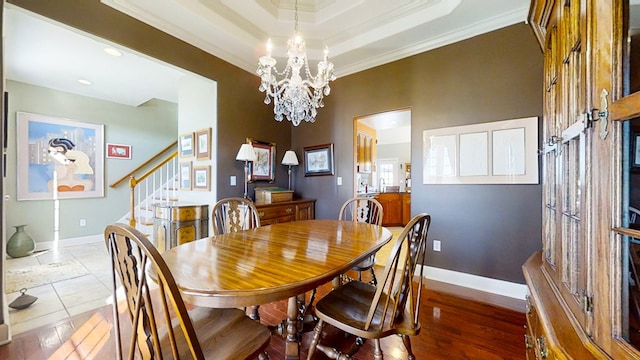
5,242,112,335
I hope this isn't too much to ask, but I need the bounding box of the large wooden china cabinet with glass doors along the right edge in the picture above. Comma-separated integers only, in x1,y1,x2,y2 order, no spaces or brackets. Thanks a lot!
523,0,640,359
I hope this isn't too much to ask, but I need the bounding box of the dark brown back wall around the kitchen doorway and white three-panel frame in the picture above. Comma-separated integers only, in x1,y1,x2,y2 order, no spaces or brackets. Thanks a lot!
292,24,542,283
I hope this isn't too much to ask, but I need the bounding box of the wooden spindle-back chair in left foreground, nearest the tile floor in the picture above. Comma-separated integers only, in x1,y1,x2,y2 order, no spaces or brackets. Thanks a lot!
104,224,271,359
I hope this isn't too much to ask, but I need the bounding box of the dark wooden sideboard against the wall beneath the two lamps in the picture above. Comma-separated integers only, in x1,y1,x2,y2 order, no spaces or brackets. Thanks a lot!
255,199,316,225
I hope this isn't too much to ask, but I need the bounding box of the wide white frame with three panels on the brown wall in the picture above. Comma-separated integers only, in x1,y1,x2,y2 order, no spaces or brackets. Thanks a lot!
422,117,539,184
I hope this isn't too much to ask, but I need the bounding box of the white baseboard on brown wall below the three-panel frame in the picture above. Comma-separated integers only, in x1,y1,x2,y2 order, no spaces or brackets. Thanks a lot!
423,266,527,300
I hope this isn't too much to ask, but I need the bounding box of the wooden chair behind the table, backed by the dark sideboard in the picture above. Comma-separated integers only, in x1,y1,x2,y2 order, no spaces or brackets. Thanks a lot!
211,197,260,235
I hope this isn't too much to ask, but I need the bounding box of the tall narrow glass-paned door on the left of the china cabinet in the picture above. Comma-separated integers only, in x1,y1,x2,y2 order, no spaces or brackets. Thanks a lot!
541,0,592,333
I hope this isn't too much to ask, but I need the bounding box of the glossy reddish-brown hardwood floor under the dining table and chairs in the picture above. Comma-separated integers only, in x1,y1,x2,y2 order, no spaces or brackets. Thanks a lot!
0,278,525,360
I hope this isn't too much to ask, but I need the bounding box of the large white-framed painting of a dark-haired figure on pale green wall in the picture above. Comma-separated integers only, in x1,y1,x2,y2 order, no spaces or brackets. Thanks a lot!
16,112,104,200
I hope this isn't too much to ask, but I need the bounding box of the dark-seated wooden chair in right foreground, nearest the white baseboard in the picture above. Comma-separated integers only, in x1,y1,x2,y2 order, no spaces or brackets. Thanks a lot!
307,214,431,360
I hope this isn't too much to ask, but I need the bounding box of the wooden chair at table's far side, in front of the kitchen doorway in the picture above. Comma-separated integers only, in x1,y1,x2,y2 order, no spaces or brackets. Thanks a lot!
338,197,384,285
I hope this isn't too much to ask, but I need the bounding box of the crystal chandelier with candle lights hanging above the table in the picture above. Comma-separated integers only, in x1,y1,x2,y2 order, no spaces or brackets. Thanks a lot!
257,1,336,126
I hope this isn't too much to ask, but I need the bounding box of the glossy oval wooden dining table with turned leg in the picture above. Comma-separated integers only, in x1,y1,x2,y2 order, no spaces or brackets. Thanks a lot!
162,220,392,359
